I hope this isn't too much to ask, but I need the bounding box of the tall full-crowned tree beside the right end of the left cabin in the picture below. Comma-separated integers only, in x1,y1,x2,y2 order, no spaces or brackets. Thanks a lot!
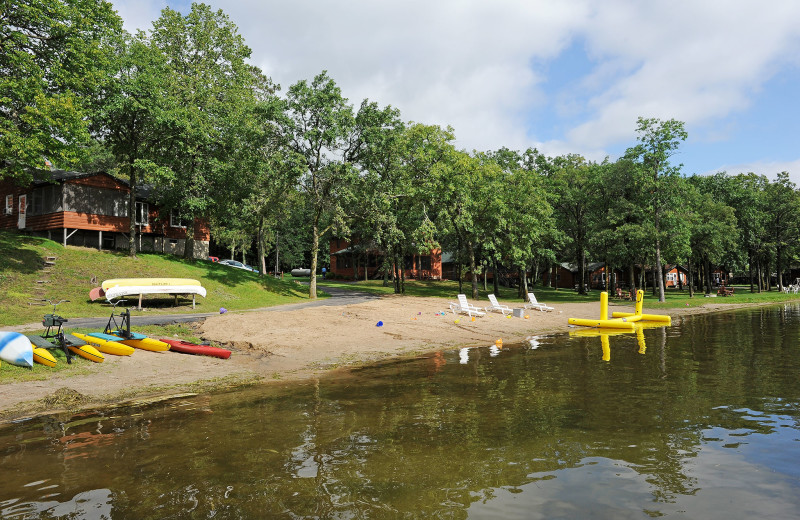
151,3,265,258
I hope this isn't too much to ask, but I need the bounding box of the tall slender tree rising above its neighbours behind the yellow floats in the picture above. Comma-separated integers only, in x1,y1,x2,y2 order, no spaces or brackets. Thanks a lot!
625,117,688,302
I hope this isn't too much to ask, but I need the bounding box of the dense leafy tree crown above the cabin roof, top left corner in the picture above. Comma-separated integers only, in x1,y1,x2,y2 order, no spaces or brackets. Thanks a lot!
0,0,122,181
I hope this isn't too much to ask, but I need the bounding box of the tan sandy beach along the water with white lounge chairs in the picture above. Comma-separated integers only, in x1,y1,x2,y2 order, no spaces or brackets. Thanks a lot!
0,295,776,424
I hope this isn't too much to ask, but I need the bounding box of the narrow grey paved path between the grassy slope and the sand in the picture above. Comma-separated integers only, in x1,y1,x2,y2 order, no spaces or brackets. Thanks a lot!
15,287,380,330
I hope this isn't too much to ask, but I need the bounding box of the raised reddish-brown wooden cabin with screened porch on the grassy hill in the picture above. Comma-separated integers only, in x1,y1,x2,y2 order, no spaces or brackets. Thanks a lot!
0,170,210,258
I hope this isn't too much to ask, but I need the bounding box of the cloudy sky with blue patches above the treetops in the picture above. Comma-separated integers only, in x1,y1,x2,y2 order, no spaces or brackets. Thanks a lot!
112,0,800,184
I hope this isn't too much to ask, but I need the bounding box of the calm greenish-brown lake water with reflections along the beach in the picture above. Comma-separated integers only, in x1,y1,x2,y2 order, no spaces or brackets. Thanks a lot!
0,305,800,519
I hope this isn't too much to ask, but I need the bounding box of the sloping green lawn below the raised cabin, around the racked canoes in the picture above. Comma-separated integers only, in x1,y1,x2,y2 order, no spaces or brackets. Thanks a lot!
0,231,308,326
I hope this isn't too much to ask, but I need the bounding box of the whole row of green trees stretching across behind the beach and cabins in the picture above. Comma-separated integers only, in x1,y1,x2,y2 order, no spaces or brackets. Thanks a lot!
0,0,800,300
